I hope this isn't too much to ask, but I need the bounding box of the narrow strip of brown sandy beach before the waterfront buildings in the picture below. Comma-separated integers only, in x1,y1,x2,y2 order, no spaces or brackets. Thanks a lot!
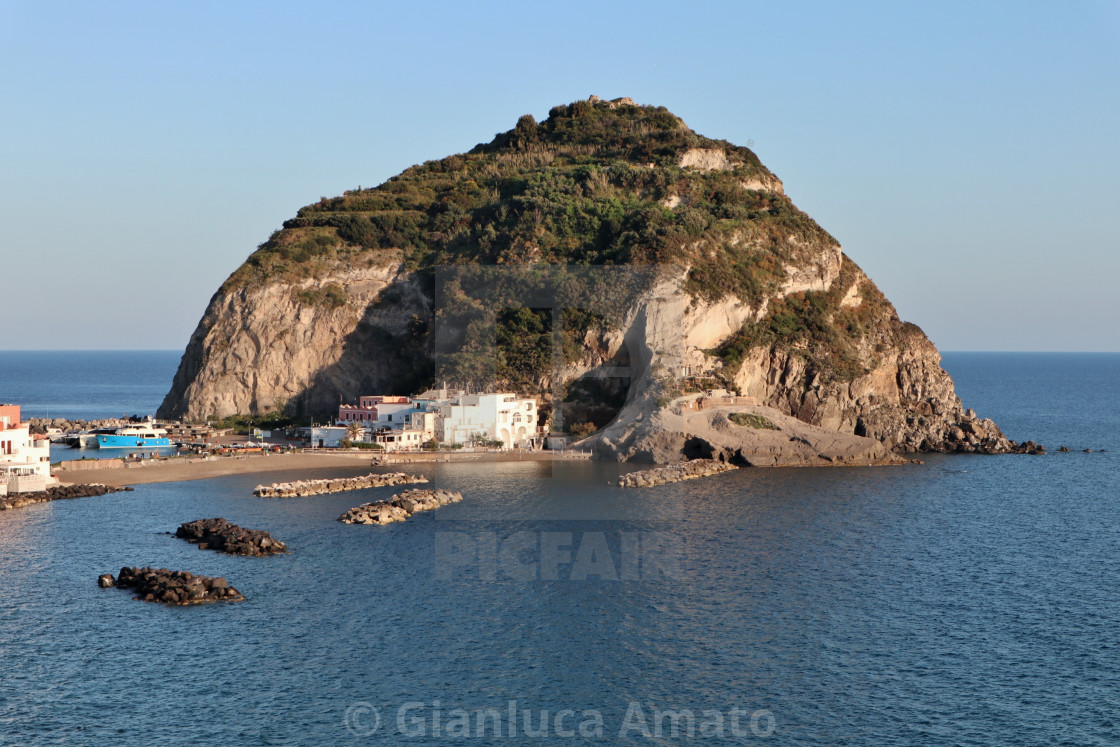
55,451,591,487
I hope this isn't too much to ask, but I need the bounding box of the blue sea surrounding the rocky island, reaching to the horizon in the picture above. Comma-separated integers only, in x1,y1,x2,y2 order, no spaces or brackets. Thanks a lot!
0,353,1120,746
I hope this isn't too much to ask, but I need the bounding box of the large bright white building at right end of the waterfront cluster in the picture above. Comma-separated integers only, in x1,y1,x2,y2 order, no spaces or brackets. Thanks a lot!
436,392,536,448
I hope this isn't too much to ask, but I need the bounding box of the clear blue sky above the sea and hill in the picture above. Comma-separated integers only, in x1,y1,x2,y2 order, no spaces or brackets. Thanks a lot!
0,0,1120,351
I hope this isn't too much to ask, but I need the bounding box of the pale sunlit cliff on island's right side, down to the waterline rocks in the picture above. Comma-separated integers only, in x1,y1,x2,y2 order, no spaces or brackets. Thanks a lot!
586,262,1037,465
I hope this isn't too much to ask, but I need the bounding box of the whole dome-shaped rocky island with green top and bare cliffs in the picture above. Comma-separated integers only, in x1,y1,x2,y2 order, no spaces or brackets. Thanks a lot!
159,96,1039,466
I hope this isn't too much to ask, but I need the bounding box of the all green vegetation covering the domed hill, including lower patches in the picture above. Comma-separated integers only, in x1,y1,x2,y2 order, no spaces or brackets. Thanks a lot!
216,100,853,405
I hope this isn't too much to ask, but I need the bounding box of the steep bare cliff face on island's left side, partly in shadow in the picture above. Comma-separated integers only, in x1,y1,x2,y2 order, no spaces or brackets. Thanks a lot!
159,261,431,420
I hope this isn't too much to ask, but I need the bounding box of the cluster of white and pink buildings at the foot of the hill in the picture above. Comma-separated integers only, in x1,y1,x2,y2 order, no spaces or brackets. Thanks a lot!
333,389,538,451
